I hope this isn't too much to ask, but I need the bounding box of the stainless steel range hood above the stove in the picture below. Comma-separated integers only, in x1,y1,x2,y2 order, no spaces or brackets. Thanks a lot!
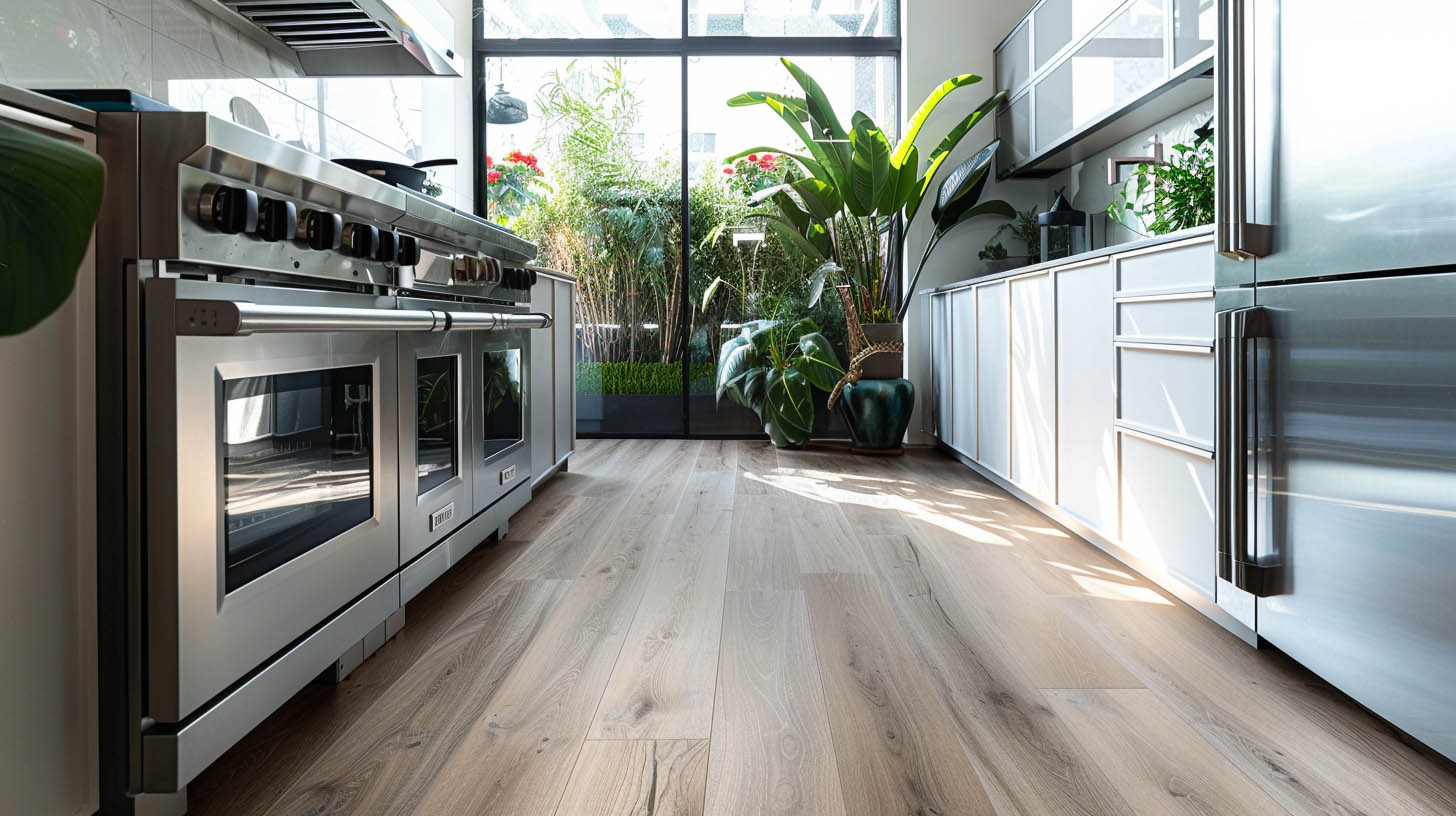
197,0,464,76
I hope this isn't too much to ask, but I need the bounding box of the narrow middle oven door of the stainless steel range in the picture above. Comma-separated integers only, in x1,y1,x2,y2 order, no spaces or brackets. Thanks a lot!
399,299,475,565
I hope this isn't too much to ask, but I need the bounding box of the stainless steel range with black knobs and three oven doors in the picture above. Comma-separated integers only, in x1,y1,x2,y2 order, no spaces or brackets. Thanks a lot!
92,112,552,793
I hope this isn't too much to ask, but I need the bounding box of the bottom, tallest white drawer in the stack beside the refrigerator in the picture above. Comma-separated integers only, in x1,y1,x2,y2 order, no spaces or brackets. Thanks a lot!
1118,431,1216,597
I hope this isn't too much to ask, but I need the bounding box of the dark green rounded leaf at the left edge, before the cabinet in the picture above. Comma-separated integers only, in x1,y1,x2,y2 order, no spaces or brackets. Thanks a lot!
0,122,105,335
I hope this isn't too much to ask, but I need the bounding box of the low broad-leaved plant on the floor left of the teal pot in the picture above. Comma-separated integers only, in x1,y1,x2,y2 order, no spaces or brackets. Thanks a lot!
718,318,844,447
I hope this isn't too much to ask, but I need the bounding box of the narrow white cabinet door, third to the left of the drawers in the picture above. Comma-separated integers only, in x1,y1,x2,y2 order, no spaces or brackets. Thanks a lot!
976,281,1010,478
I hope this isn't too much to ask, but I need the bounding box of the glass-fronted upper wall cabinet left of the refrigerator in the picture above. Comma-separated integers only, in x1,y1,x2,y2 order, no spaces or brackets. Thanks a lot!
996,0,1214,176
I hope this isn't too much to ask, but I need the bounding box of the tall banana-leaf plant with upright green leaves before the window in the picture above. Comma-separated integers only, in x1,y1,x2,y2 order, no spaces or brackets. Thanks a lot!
728,60,1015,322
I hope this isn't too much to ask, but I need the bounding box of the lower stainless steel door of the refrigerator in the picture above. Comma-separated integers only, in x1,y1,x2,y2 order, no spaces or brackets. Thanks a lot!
1251,272,1456,758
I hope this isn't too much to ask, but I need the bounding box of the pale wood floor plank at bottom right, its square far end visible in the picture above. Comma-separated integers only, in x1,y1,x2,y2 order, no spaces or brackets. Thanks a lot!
1042,689,1284,816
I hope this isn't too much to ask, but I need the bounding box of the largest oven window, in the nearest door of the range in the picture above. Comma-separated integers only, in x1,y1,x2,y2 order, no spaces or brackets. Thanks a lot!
223,366,374,592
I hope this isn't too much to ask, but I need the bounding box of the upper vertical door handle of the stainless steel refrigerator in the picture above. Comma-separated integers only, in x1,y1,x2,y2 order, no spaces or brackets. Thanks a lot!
1214,0,1274,261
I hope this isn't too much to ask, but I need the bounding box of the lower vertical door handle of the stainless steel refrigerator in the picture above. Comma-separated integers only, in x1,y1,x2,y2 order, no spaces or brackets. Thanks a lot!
1214,306,1280,597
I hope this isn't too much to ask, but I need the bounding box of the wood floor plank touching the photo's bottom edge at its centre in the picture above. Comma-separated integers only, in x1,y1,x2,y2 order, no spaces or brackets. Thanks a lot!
705,592,846,816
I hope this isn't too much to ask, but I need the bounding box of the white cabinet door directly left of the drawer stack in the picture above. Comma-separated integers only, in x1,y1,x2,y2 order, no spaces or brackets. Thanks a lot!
1056,259,1118,538
